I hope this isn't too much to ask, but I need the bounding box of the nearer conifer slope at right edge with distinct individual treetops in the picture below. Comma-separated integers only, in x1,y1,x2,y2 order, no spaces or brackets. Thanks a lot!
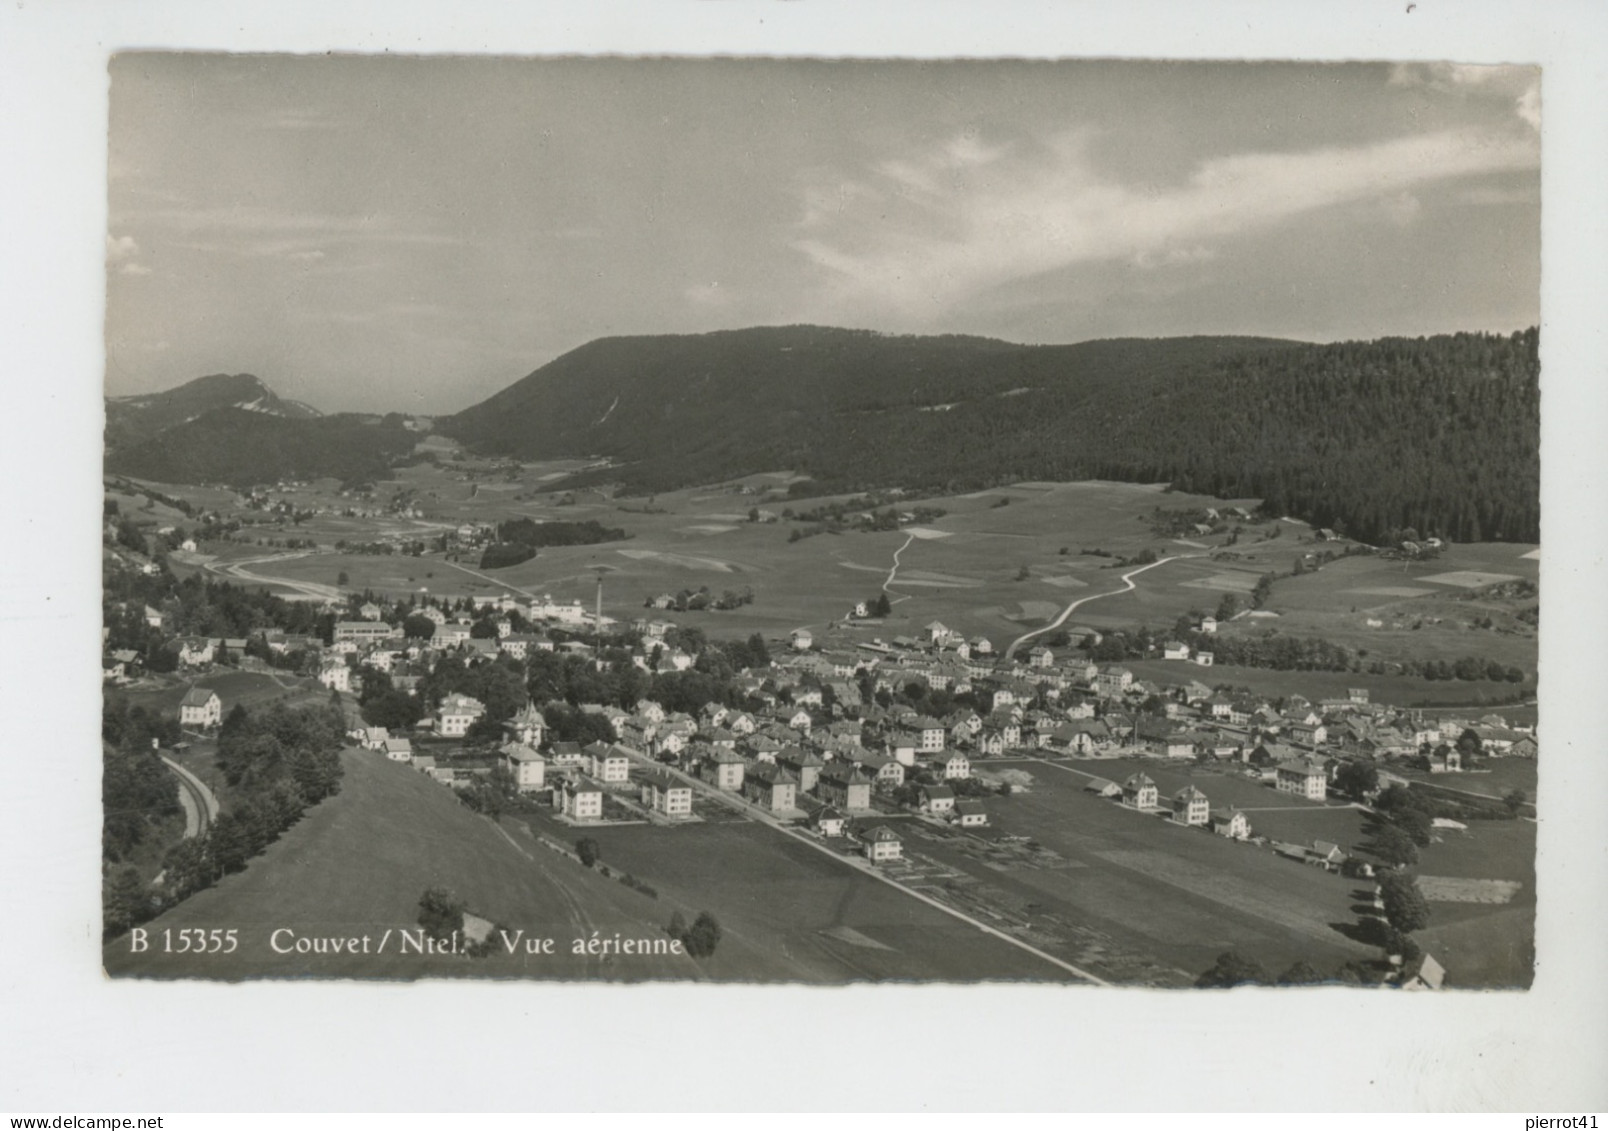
1089,330,1540,542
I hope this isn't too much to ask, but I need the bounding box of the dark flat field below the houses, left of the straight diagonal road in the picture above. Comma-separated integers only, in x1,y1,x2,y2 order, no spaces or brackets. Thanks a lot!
517,804,1071,981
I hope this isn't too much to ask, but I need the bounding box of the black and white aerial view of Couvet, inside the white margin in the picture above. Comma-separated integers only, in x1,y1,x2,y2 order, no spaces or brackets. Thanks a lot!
101,51,1544,991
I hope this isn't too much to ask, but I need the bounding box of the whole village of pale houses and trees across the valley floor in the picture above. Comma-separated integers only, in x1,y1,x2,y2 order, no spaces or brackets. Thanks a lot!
105,543,1537,986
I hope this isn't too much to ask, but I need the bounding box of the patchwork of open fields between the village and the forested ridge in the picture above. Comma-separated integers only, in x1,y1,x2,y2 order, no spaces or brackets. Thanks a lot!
147,462,1539,705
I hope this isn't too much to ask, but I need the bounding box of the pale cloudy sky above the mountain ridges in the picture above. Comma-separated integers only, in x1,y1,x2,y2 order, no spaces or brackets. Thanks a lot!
106,53,1540,412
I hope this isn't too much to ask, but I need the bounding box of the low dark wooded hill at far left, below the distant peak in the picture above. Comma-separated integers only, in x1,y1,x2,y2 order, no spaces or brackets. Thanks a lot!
106,409,418,486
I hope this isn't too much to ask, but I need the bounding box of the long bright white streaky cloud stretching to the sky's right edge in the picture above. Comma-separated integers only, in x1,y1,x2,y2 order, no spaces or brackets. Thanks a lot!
793,130,1539,319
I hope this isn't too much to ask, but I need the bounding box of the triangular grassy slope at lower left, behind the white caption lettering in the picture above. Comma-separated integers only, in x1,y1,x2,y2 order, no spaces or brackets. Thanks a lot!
103,750,704,980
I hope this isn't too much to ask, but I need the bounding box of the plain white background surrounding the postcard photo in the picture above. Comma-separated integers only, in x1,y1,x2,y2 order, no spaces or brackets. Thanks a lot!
0,0,1608,1128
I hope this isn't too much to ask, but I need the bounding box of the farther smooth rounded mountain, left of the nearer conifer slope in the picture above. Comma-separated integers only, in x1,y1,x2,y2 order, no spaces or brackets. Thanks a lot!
436,327,1291,491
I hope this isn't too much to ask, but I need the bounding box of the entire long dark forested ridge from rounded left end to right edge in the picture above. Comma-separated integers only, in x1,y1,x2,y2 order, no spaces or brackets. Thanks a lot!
437,327,1540,541
